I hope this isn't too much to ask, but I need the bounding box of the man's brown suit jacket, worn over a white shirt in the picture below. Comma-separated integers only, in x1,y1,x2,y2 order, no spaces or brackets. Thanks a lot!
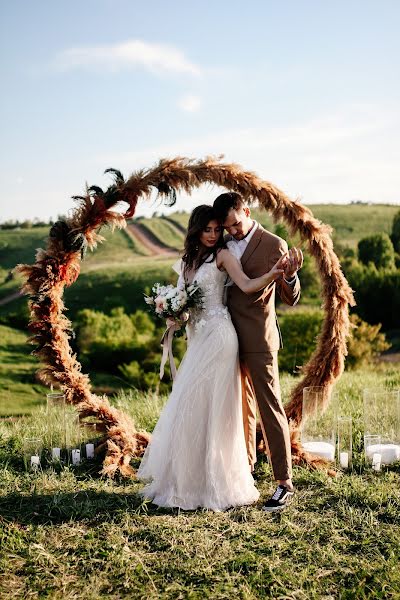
227,224,300,354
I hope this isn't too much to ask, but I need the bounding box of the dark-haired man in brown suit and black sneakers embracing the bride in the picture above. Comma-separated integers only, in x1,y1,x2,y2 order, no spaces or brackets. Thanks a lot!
214,192,303,512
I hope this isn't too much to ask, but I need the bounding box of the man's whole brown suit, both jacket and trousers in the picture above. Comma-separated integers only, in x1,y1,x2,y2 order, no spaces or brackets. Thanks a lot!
227,225,300,480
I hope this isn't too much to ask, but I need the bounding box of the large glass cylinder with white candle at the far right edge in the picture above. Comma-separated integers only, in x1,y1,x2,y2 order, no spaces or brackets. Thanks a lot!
363,388,400,465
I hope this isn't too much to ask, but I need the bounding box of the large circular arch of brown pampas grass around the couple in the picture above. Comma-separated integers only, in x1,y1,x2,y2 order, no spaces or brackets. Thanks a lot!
17,157,354,476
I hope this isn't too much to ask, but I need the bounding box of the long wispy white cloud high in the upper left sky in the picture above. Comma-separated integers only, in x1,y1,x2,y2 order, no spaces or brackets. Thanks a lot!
55,40,202,76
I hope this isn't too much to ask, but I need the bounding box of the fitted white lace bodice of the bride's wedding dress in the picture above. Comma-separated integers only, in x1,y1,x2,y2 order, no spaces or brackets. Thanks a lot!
180,260,230,333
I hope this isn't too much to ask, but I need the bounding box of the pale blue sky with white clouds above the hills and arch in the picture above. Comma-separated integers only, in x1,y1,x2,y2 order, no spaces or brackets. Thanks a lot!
0,0,400,221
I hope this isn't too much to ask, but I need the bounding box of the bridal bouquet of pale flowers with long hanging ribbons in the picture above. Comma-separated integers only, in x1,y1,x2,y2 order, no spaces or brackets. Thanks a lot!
144,281,204,379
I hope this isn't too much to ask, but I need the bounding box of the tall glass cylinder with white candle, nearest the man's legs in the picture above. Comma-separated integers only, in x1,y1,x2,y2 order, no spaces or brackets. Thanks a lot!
301,386,335,460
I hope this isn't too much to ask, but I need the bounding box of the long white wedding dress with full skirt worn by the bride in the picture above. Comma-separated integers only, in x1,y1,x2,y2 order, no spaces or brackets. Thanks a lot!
138,260,259,511
